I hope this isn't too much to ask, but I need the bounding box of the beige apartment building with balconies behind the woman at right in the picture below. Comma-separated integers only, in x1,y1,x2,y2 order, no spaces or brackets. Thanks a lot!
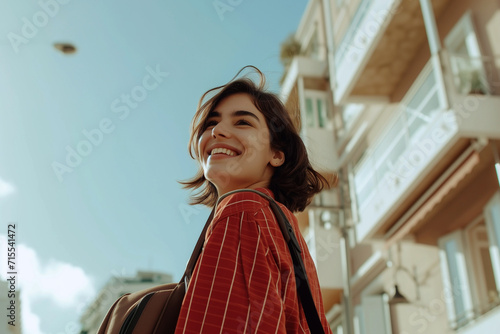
281,0,500,334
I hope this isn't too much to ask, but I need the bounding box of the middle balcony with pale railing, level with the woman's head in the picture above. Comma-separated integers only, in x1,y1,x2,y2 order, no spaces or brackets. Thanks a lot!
353,56,500,241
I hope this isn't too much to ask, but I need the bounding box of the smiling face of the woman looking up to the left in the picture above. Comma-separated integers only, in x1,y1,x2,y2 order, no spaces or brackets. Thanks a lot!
198,93,284,196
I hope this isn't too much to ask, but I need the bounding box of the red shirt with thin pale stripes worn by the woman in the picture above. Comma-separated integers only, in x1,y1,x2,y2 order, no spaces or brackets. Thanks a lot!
175,188,331,334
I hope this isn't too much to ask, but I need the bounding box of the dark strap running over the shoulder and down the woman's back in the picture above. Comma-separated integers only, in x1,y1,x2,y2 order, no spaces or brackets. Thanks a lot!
217,189,325,334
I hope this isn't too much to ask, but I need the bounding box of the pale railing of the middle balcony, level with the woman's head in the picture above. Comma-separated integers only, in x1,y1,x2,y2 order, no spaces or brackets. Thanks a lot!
354,54,500,211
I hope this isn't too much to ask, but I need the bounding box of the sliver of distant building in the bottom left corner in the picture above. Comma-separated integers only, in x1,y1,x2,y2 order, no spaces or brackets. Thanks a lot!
0,281,22,334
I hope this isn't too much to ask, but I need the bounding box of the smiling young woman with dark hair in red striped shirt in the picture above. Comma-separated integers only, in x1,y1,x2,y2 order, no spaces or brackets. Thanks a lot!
176,67,331,334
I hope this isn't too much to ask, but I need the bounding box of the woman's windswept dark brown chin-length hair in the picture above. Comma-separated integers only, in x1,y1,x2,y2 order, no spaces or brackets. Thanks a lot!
180,66,333,212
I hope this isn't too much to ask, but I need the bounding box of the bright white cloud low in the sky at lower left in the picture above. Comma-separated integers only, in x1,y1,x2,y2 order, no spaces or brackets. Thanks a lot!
0,235,96,334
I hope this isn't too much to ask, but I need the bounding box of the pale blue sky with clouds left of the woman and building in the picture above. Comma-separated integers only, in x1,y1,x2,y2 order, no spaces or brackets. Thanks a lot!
0,0,307,334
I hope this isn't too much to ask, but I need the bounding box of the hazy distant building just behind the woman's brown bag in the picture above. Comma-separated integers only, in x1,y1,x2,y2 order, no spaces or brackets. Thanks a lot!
80,271,172,334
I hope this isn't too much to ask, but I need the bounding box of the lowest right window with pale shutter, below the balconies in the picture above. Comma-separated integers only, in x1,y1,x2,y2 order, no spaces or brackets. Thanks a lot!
439,192,500,328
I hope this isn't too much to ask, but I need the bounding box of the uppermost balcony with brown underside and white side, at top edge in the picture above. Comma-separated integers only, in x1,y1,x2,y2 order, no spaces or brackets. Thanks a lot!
335,0,456,104
